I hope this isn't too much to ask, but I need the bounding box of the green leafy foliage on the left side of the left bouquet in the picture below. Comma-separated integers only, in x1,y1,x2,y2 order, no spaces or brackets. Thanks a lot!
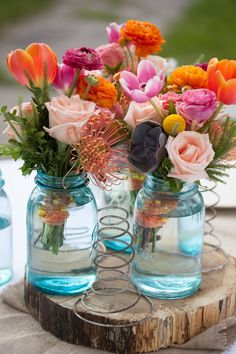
0,82,69,176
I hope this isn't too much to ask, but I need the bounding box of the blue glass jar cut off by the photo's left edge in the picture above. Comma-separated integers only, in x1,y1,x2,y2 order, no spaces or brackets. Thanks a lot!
0,170,12,285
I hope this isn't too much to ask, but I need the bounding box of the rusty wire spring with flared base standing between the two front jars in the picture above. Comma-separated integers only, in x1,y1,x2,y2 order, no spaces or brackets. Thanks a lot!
74,205,153,327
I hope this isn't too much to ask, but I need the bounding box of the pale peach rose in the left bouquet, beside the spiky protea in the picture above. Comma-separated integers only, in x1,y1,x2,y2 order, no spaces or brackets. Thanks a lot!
44,95,96,144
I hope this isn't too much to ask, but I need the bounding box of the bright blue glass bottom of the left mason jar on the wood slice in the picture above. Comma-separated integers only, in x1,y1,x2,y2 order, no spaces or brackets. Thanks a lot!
27,270,96,296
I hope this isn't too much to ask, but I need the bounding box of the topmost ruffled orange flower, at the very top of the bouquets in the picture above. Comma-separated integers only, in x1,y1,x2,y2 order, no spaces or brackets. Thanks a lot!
119,20,165,57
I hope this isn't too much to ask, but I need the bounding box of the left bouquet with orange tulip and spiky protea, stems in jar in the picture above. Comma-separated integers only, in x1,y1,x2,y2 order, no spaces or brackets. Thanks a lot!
0,43,129,254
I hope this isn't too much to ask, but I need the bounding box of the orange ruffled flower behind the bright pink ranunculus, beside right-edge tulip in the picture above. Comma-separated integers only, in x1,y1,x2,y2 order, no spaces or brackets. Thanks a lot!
167,65,207,92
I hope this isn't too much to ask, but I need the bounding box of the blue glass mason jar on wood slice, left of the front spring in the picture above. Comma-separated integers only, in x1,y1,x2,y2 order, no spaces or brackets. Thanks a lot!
27,172,98,295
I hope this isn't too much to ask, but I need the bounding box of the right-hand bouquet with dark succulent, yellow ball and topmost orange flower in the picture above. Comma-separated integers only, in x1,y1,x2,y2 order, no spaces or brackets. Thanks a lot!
94,20,236,252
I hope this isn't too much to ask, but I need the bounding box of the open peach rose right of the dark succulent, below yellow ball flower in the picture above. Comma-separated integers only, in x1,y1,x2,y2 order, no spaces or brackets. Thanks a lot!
166,131,215,182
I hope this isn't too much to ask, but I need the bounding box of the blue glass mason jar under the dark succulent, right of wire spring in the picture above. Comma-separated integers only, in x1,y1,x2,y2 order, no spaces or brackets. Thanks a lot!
131,174,205,299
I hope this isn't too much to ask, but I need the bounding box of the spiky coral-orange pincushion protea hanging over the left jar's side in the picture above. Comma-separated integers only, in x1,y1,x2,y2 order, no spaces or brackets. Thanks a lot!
75,112,128,189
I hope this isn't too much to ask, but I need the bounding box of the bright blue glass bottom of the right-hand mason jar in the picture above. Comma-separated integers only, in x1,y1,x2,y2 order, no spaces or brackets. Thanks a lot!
132,271,201,300
